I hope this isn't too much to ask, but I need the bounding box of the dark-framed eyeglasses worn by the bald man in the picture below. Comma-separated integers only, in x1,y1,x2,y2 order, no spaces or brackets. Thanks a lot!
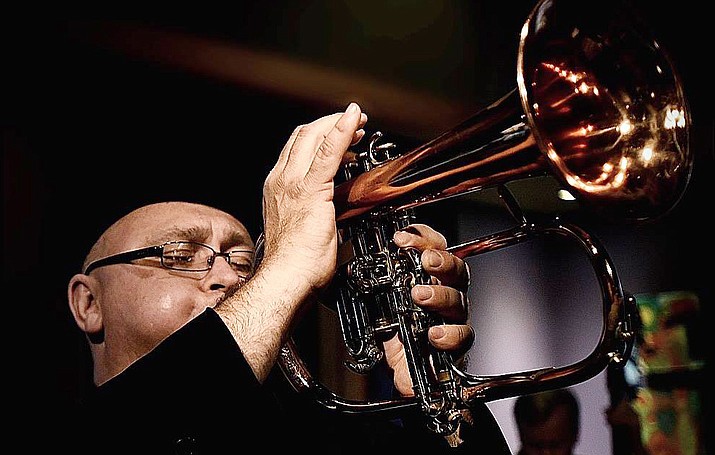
84,241,254,278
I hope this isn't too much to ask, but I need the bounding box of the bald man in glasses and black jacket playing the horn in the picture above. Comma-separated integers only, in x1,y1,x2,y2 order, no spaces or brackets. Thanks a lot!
63,104,509,454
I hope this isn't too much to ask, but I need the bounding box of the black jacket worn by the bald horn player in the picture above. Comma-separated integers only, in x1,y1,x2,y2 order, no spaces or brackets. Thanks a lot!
69,309,510,455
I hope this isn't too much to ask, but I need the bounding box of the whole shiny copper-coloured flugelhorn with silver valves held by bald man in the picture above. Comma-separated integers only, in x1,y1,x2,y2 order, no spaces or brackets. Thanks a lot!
270,0,693,446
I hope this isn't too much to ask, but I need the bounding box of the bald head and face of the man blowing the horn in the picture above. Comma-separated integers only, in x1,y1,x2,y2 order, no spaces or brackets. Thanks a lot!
68,202,254,384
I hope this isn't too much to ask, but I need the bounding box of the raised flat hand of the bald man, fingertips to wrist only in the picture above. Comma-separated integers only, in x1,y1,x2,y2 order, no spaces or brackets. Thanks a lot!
262,103,367,291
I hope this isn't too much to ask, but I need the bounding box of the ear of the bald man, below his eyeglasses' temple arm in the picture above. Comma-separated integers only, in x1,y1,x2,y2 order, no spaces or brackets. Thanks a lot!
67,273,104,343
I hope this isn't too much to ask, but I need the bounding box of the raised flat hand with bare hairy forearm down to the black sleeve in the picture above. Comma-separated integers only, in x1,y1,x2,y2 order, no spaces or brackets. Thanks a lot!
221,104,367,382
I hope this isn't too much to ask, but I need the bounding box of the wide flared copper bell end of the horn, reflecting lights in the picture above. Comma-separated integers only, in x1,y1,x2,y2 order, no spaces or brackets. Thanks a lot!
517,0,693,222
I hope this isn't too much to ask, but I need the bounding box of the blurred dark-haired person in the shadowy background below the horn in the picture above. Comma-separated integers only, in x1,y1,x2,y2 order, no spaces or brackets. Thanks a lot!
514,389,581,455
